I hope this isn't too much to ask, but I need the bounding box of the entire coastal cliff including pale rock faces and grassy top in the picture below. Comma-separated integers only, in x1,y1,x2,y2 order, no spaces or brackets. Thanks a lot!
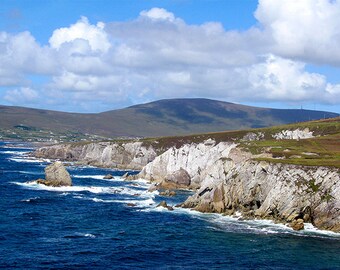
34,118,340,232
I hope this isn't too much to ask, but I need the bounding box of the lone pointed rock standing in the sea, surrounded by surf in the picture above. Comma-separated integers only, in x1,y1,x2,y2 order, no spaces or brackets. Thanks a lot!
37,161,72,187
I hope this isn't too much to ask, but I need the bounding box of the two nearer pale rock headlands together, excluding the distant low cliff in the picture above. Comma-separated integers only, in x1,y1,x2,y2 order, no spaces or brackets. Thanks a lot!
139,139,340,232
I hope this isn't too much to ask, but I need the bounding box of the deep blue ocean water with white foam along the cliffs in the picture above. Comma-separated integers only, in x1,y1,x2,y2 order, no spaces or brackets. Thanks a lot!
0,142,340,269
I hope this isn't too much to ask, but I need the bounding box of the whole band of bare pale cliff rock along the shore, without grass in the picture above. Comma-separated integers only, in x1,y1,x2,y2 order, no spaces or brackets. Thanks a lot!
34,139,340,232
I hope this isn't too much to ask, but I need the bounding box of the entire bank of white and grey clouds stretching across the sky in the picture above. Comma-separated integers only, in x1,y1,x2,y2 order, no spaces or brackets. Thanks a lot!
0,0,340,110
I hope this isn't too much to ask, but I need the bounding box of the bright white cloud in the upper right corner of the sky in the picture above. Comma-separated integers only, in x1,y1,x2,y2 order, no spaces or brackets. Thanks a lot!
255,0,340,66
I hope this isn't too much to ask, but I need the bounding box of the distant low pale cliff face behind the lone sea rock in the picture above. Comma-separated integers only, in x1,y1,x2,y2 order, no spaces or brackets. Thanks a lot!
33,142,157,170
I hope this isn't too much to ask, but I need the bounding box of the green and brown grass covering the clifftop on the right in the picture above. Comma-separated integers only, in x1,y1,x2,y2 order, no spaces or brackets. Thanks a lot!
141,117,340,168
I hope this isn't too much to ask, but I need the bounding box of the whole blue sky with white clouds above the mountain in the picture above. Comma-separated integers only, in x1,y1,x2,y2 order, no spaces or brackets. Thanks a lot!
0,0,340,113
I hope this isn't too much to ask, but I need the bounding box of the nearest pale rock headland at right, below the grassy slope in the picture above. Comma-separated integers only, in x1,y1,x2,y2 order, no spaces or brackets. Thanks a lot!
183,160,340,231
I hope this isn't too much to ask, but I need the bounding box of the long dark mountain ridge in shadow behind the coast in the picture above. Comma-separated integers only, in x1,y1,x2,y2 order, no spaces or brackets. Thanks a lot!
0,99,339,140
